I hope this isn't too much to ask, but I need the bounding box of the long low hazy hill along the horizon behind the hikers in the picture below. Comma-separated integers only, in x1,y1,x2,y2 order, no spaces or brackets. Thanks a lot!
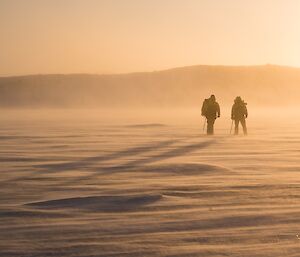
0,65,300,108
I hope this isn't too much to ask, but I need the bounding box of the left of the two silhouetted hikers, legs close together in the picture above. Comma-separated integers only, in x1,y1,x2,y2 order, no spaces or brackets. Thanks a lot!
201,95,220,135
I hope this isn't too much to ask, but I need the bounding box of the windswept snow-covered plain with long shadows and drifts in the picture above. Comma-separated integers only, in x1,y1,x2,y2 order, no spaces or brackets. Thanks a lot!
0,109,300,257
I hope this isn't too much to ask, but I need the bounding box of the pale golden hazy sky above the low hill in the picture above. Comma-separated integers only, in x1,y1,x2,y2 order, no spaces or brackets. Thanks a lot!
0,0,300,76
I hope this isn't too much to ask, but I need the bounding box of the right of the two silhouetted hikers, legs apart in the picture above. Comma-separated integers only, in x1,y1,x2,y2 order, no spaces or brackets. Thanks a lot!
231,96,248,135
